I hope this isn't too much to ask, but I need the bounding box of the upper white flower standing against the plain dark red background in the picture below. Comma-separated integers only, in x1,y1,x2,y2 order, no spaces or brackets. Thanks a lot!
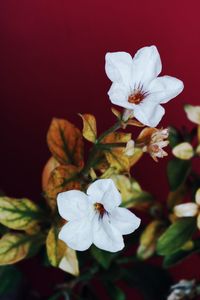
105,46,183,127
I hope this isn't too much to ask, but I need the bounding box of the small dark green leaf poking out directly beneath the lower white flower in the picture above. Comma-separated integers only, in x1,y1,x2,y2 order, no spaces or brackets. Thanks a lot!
90,246,118,269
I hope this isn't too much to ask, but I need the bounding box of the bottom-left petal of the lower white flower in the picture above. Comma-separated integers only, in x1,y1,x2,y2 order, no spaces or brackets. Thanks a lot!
58,218,92,251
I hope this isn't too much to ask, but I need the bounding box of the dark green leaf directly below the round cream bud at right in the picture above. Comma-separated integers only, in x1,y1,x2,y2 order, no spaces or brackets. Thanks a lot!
167,158,191,191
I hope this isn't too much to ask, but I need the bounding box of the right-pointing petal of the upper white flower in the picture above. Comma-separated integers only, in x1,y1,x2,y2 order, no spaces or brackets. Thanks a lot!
148,76,184,103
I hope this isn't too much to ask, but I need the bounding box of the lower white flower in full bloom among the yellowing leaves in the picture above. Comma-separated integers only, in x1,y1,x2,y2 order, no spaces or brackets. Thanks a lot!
57,179,140,252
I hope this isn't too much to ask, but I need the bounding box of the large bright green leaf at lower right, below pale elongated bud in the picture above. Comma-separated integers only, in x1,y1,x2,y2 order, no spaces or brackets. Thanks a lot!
157,217,196,256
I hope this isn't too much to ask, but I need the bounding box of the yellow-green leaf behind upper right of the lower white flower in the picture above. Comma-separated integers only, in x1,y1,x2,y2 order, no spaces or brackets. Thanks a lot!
110,175,153,210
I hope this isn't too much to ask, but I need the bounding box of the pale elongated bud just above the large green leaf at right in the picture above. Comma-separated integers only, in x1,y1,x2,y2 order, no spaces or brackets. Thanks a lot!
174,202,198,218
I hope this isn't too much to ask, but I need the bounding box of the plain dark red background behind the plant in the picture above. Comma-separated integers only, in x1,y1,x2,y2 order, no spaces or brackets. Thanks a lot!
0,0,200,298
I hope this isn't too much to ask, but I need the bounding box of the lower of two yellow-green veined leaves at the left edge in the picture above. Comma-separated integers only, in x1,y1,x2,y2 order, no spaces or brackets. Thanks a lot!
0,233,43,265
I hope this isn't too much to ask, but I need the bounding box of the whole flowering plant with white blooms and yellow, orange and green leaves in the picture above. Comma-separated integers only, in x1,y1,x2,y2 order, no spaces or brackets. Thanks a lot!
0,46,200,300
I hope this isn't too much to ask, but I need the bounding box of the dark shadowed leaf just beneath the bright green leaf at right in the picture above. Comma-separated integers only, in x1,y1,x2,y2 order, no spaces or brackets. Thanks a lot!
163,240,200,268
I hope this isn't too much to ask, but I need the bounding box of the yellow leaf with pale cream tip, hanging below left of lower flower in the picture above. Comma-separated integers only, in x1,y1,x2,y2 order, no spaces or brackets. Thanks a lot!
46,226,79,276
